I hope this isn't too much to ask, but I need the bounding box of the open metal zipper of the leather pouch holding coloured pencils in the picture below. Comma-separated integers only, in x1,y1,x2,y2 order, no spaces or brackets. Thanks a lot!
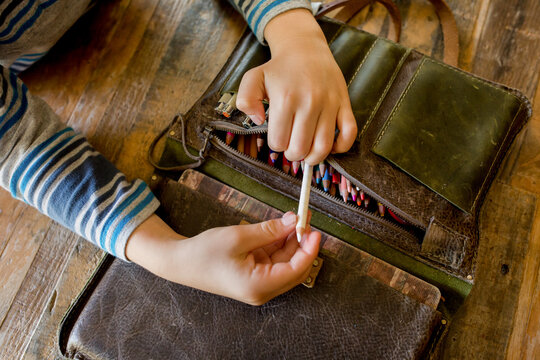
208,120,425,240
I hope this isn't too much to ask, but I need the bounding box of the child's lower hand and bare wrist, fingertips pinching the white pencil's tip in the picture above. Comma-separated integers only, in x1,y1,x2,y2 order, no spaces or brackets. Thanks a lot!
127,213,321,305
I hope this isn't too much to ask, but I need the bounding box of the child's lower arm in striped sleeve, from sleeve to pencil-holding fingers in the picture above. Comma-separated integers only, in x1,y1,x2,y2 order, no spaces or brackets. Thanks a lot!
0,62,320,304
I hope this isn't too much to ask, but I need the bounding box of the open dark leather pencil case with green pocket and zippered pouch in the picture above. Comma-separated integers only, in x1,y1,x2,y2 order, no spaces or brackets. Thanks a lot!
161,11,531,283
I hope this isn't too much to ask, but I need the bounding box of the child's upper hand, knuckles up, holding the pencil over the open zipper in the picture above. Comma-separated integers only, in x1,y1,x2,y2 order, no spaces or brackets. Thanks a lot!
236,9,357,165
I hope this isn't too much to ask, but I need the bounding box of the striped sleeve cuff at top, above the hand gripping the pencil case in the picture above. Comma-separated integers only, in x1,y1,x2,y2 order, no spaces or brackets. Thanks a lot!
230,0,311,43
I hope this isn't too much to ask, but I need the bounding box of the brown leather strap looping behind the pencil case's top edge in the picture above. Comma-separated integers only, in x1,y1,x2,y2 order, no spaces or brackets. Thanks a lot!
316,0,459,67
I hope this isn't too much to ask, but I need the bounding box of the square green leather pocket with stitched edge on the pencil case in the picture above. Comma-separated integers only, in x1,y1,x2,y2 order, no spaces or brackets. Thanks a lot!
372,58,521,213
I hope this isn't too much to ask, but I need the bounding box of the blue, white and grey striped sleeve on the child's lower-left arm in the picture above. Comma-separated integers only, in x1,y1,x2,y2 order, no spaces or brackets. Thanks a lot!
0,67,159,260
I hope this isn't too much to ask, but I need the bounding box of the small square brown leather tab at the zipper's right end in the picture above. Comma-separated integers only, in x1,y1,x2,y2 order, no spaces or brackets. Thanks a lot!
421,218,469,269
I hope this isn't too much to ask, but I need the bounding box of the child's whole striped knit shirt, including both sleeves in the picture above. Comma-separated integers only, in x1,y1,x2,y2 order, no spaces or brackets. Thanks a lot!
0,0,310,260
